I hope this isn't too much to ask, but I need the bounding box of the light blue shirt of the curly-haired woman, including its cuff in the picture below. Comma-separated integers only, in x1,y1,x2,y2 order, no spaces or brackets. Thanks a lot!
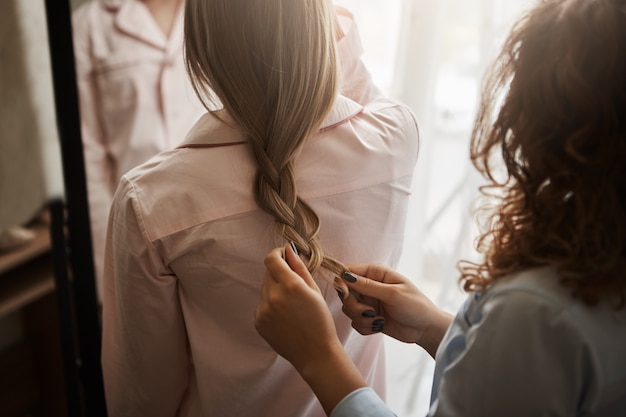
331,267,626,417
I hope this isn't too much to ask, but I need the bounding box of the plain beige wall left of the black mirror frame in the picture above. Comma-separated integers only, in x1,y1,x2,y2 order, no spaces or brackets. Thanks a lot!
0,0,63,364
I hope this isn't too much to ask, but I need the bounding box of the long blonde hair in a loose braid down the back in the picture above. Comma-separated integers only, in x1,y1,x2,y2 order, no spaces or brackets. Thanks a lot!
185,0,345,274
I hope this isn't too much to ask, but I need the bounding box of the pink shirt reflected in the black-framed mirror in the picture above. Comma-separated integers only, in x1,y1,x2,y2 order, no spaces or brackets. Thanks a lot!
72,0,206,293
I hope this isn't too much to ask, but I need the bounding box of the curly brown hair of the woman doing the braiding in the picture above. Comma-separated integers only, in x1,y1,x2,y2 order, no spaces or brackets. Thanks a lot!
459,0,626,308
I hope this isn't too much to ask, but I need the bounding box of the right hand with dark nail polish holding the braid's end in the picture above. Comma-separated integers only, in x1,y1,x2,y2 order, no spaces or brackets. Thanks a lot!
342,265,452,357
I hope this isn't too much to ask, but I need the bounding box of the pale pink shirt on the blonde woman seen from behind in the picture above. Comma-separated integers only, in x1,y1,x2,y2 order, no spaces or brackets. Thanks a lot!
102,5,418,417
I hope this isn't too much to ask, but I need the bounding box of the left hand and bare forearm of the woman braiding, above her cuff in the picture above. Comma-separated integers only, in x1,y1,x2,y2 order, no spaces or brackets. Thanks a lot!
255,245,367,415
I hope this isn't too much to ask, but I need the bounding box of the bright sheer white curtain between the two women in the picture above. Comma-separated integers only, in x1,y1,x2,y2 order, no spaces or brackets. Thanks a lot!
335,0,534,417
